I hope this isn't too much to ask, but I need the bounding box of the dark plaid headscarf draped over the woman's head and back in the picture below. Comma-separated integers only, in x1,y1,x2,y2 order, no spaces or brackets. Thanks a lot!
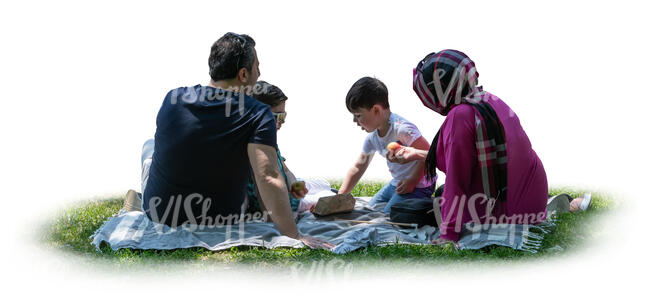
413,50,508,201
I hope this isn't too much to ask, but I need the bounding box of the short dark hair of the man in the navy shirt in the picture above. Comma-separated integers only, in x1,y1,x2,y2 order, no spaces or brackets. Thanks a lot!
208,32,255,82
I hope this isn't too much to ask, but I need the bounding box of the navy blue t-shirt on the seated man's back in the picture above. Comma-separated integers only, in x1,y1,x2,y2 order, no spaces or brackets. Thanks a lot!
143,85,277,226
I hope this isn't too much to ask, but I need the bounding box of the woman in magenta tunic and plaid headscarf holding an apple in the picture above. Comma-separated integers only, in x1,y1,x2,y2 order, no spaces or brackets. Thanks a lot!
391,50,548,244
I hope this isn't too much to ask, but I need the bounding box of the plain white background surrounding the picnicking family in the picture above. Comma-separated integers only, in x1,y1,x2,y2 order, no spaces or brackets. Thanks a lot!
0,1,650,303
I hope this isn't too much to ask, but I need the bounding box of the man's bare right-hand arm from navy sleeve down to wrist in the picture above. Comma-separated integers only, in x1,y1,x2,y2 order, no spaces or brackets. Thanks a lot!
248,143,299,239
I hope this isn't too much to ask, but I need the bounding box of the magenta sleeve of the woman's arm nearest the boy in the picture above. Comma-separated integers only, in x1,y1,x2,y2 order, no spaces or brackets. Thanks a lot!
437,105,477,241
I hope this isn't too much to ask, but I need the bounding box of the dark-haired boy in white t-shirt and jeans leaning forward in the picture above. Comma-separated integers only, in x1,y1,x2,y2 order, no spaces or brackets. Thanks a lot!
339,77,435,213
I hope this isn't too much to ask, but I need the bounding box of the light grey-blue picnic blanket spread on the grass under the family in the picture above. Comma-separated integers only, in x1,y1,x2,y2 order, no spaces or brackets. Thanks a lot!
90,197,554,254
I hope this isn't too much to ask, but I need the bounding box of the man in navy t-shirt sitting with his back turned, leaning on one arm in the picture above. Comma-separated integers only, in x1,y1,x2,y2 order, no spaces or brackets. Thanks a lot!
142,33,331,247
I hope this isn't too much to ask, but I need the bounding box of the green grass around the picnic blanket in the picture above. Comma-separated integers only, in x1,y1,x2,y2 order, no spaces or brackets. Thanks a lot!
43,182,614,267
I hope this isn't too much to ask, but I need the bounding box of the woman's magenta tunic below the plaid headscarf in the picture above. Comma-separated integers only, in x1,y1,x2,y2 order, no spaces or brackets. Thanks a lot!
436,92,548,241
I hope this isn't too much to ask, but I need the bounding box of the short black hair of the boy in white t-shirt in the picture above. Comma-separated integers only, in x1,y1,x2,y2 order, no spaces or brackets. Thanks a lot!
345,77,390,112
